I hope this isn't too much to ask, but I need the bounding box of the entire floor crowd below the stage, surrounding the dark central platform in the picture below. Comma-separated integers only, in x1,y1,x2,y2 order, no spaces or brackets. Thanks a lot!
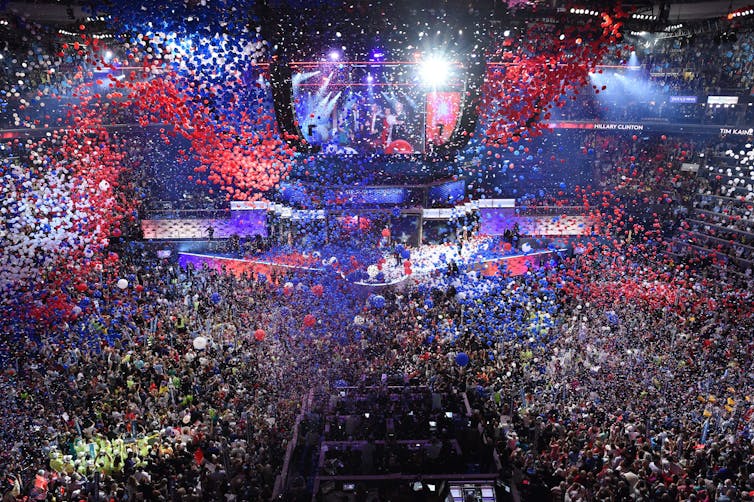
1,229,754,500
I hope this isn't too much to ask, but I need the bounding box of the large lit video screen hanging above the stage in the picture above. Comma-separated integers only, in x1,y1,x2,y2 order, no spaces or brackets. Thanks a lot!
293,62,463,155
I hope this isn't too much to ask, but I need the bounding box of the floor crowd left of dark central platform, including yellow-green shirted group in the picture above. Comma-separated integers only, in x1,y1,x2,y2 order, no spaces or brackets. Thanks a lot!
2,245,358,500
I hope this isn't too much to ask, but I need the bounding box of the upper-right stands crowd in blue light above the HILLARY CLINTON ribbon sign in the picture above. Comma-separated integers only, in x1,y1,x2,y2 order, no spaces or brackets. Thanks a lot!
555,30,754,126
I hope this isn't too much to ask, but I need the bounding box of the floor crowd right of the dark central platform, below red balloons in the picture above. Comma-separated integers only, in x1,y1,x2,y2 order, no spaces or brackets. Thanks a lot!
406,255,754,500
